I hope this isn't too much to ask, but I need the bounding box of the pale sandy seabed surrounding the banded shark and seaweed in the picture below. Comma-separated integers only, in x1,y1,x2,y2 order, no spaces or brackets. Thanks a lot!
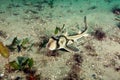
0,0,120,80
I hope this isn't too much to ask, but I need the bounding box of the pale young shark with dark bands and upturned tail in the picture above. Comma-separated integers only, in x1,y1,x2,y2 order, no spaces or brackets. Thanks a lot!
46,16,88,52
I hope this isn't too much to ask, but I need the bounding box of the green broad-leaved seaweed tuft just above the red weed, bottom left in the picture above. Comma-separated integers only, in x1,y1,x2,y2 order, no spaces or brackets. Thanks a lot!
5,56,34,73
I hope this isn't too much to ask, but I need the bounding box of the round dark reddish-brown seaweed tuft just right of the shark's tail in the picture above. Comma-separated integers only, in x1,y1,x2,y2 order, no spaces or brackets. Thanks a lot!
93,28,106,41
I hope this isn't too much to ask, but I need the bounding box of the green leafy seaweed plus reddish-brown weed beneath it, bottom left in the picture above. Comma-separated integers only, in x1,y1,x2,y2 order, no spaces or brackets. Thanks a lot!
5,56,41,80
